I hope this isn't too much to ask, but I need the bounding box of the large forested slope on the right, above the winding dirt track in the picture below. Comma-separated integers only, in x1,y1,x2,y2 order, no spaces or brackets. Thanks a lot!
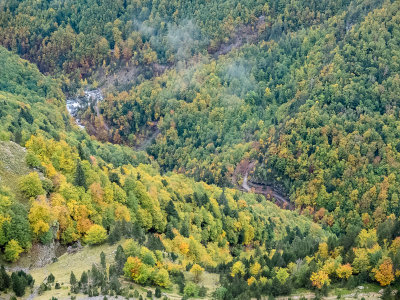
80,2,400,233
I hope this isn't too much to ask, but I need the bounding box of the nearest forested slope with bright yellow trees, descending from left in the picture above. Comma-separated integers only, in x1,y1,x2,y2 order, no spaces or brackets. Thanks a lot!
0,49,329,298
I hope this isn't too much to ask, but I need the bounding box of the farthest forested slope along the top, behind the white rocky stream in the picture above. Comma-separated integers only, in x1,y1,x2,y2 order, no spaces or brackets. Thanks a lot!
0,0,350,91
